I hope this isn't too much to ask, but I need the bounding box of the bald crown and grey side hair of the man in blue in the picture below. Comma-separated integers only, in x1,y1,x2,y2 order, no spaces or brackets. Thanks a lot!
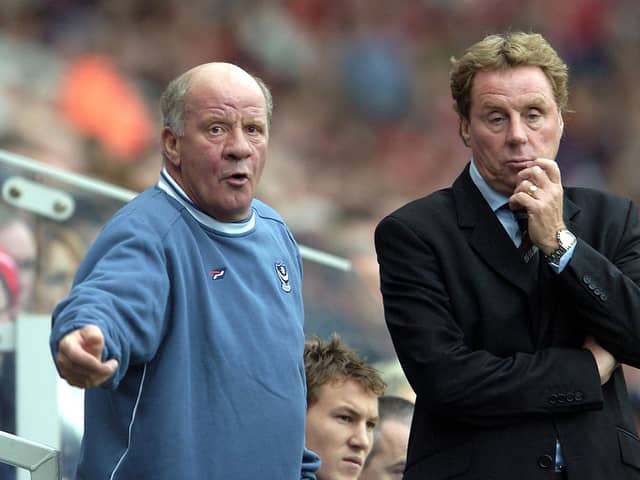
160,62,273,136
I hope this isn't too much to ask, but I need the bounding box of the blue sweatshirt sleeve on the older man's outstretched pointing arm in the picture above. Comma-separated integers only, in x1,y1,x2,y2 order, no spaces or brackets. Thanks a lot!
50,215,169,388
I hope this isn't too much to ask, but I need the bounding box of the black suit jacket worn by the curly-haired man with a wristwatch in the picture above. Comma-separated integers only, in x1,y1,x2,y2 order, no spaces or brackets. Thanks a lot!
375,167,640,480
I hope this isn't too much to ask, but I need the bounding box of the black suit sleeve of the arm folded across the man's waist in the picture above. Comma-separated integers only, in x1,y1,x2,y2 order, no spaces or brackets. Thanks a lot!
376,218,602,424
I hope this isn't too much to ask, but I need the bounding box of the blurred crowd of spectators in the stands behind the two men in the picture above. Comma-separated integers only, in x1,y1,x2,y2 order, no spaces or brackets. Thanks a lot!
0,0,640,428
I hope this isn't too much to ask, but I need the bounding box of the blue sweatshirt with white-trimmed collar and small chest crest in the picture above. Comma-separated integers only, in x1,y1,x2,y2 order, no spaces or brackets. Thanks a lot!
50,171,319,480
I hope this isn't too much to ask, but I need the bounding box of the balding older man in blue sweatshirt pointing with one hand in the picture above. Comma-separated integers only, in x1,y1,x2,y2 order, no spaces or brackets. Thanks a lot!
51,63,319,480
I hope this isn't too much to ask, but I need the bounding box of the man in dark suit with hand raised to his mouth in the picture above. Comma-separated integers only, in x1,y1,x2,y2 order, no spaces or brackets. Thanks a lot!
375,32,640,480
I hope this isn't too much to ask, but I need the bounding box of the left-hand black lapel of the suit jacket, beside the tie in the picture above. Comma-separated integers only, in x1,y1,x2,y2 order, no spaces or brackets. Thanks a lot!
452,166,531,292
